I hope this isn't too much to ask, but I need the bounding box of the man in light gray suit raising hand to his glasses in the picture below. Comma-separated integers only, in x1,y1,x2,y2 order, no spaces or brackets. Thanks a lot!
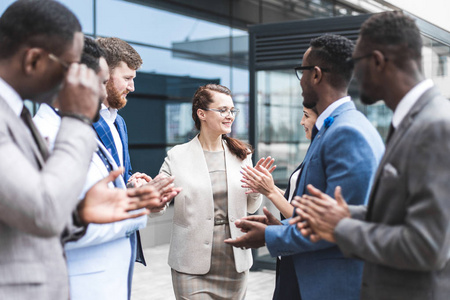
0,0,159,300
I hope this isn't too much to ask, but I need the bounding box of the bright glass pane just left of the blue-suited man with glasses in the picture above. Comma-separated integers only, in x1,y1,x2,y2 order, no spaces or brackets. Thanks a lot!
256,70,302,187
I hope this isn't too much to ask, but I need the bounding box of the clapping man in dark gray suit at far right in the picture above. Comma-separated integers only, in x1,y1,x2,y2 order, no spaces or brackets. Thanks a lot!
296,12,450,300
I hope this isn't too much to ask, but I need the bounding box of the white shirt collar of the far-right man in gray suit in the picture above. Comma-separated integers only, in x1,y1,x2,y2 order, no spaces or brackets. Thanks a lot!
392,79,434,128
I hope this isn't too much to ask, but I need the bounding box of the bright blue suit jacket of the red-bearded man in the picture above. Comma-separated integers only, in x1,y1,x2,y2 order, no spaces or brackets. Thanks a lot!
94,114,132,183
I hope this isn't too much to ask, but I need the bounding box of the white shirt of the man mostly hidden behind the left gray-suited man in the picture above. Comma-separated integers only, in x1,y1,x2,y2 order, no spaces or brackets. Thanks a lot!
35,105,147,300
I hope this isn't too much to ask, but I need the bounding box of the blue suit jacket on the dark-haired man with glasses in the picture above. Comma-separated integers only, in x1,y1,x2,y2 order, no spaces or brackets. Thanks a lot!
265,102,384,300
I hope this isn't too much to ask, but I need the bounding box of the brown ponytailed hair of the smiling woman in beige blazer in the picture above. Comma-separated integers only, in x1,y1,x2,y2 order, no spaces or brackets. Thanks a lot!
192,83,253,160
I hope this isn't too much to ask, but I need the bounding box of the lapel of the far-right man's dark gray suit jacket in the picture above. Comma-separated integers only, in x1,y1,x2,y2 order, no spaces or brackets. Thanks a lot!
366,88,439,220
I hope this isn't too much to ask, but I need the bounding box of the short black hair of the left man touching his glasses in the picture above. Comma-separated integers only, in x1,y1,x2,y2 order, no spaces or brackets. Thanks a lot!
0,0,81,59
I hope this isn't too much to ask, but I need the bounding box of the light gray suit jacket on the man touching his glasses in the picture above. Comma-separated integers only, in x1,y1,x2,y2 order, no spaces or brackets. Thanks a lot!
0,97,96,300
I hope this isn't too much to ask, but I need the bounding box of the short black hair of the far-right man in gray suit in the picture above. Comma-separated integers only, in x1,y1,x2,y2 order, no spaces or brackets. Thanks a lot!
360,11,422,68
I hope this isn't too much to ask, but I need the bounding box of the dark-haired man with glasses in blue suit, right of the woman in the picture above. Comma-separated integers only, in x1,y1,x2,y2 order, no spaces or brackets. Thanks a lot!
227,35,384,300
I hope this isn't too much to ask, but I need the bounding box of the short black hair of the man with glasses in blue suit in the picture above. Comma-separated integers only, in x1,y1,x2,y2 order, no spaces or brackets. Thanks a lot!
308,34,355,88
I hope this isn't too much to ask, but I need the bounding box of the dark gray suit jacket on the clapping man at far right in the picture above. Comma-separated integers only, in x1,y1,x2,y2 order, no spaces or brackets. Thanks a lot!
335,85,450,300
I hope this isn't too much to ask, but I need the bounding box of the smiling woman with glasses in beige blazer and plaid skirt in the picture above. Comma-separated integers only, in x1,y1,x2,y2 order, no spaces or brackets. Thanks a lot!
160,84,262,299
